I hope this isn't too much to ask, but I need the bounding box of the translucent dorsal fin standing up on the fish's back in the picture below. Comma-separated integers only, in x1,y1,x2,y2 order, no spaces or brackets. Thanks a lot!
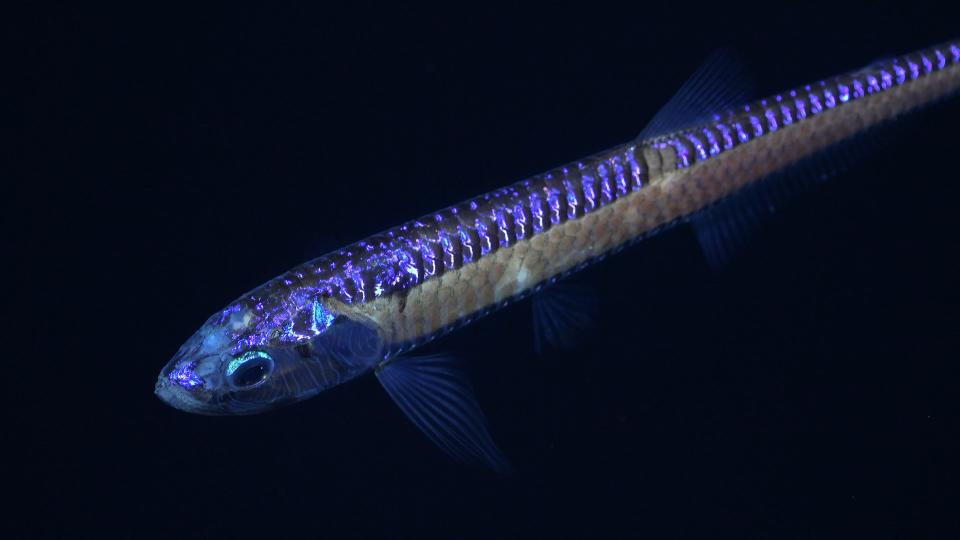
637,50,753,140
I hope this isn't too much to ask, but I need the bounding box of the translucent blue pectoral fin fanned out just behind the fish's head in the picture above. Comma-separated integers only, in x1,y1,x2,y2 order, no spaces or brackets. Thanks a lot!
376,356,510,474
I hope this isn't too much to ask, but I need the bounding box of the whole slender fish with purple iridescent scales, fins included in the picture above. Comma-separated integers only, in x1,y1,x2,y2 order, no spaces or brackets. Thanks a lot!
155,40,960,472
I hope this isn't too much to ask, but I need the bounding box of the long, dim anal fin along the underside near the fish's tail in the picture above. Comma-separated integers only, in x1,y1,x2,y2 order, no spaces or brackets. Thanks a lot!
691,122,891,271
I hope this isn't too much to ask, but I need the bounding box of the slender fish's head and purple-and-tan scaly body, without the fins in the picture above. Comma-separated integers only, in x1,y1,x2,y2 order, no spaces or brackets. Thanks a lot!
156,41,960,420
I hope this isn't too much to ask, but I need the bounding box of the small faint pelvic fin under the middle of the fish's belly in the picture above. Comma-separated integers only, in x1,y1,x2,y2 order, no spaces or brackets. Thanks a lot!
533,282,597,354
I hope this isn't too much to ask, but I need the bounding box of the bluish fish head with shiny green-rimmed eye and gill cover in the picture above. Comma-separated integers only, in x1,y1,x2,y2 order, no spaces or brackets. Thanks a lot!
155,300,384,415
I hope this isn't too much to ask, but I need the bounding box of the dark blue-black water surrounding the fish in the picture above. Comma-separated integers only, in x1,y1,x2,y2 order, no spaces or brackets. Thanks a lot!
13,2,960,538
